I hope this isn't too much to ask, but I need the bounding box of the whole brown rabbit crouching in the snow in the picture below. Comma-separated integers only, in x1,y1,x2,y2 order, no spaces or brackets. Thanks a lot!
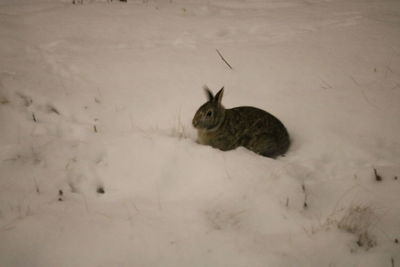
192,86,290,158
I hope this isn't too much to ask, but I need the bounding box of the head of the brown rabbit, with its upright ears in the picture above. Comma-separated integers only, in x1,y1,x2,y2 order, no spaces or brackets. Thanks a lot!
192,86,225,130
